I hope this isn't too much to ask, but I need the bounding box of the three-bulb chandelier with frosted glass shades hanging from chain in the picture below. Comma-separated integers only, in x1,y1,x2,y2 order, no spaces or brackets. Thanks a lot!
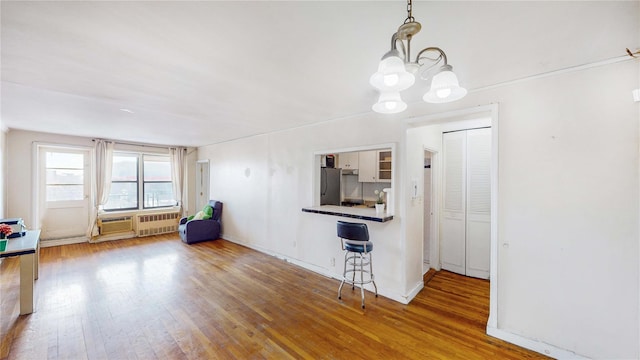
369,0,467,114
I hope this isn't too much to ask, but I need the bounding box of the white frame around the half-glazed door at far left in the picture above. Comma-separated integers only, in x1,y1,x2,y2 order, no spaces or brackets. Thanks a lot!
31,141,95,246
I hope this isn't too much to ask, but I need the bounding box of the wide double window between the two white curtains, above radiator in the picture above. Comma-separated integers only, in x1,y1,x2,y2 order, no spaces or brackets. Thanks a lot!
104,153,176,211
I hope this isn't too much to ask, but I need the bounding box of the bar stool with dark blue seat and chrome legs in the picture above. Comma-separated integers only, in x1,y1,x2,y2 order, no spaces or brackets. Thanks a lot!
338,221,378,309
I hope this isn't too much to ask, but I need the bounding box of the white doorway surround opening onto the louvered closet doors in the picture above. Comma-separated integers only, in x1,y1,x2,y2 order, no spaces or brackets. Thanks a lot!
404,104,499,327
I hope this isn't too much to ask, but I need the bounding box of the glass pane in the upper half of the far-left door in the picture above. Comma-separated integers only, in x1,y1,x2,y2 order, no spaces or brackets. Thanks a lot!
45,151,84,201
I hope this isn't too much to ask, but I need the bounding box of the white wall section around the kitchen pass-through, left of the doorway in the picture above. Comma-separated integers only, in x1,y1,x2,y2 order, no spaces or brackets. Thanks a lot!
198,115,421,301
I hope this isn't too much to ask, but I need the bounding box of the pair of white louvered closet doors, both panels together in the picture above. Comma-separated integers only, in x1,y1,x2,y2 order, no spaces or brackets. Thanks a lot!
440,128,491,279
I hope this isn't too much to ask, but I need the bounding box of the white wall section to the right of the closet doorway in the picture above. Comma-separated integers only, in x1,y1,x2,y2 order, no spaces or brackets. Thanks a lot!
498,62,639,358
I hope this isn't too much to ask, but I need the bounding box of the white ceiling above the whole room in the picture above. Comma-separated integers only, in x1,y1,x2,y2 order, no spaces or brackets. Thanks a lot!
0,1,640,146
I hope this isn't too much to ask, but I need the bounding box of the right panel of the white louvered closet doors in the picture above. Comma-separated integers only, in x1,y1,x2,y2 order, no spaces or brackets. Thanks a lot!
466,129,491,279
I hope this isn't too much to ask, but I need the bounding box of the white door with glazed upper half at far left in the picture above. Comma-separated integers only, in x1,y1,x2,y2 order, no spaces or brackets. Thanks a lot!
37,147,90,240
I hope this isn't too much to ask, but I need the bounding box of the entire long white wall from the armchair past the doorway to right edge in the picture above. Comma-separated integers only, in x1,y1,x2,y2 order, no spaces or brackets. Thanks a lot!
199,58,640,358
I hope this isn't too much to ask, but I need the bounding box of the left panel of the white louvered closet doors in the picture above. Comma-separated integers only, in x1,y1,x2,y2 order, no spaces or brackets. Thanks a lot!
440,131,466,275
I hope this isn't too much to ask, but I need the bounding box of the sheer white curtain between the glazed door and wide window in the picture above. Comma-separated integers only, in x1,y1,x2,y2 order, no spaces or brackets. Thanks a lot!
87,140,114,239
